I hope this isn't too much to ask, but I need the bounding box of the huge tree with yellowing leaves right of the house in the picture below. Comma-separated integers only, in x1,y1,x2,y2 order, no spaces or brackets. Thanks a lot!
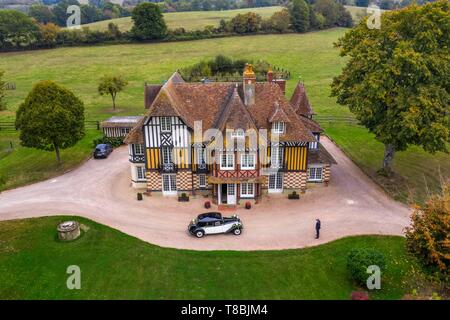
332,1,450,175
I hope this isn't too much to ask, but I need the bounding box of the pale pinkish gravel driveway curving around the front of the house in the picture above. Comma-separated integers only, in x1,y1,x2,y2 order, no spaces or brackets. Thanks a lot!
0,137,410,250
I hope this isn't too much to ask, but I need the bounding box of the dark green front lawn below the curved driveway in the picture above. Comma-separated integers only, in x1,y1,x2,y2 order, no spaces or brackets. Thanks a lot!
0,217,417,299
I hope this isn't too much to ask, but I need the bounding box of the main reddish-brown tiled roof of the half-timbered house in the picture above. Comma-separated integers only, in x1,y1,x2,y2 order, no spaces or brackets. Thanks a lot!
126,72,316,142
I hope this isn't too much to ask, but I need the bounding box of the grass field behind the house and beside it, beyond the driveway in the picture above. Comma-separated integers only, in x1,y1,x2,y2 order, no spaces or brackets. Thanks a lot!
0,28,450,201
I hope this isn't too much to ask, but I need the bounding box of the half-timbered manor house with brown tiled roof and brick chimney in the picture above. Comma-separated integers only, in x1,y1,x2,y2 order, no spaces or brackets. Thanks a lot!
125,65,335,205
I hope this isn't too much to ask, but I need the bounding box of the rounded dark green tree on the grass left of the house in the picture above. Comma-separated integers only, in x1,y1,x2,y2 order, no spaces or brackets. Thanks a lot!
16,81,84,162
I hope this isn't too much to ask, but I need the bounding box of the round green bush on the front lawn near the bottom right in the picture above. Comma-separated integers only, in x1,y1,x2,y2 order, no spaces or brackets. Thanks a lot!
347,248,386,285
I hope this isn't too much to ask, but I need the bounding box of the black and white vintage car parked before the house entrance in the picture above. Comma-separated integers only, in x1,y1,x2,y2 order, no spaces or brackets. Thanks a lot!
188,212,244,238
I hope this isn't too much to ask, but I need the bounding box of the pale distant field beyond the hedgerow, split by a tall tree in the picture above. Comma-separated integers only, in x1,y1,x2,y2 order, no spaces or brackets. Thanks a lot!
83,6,283,31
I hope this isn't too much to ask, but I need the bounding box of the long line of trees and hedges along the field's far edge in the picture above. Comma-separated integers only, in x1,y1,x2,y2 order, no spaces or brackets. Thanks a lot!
0,0,353,51
